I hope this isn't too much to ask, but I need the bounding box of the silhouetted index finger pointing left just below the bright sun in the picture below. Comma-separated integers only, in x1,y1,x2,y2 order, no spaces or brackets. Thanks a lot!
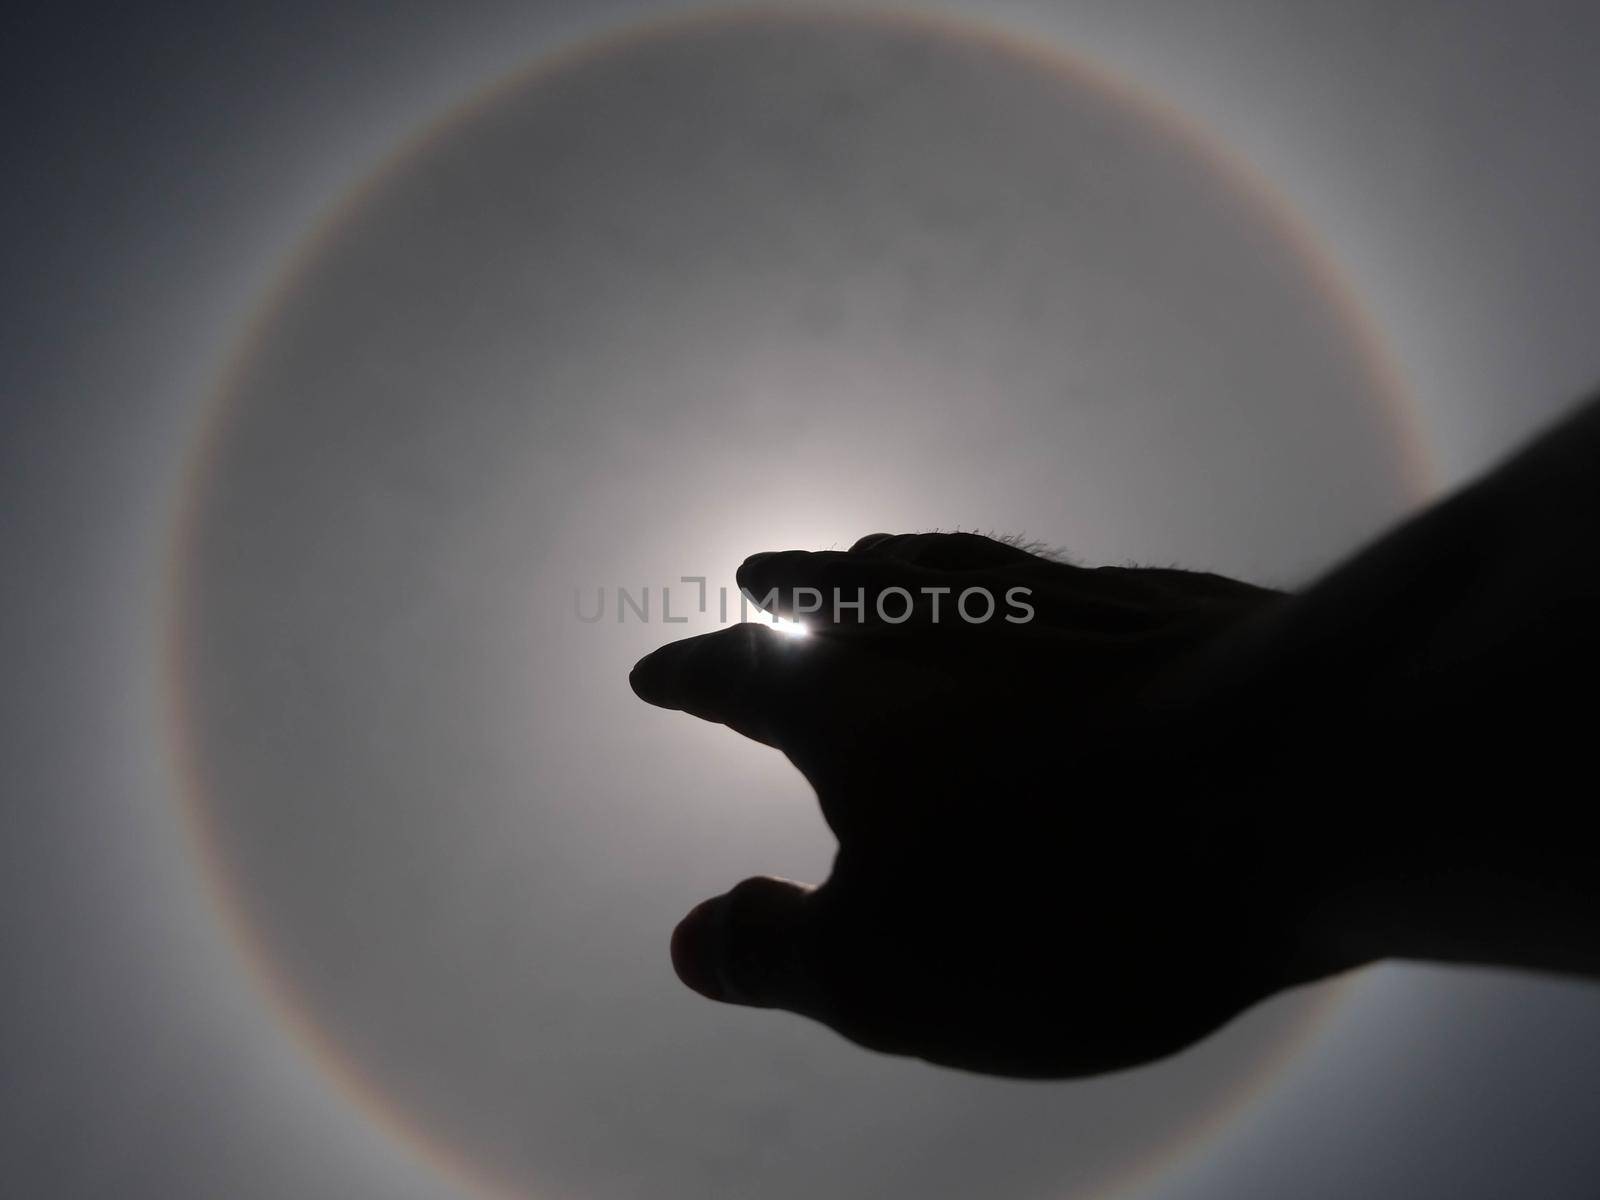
627,621,806,746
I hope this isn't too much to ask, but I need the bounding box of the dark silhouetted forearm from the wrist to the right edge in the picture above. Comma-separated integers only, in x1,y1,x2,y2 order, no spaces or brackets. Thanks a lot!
1173,395,1600,974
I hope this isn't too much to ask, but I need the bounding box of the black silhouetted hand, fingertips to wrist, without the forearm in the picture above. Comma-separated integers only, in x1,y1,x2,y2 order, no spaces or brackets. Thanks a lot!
632,534,1344,1075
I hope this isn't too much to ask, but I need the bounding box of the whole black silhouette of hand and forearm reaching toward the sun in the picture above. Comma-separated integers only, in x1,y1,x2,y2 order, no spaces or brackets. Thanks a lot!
632,390,1600,1077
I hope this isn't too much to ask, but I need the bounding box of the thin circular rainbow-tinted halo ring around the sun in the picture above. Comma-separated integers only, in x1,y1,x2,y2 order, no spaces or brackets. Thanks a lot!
162,8,1435,1200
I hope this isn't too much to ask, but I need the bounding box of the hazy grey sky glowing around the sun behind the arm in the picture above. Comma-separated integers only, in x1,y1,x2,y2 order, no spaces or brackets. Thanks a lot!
9,3,1600,1200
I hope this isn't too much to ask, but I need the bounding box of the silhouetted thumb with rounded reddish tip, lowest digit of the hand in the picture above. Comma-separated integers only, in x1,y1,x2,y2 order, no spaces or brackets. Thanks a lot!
672,875,822,1014
